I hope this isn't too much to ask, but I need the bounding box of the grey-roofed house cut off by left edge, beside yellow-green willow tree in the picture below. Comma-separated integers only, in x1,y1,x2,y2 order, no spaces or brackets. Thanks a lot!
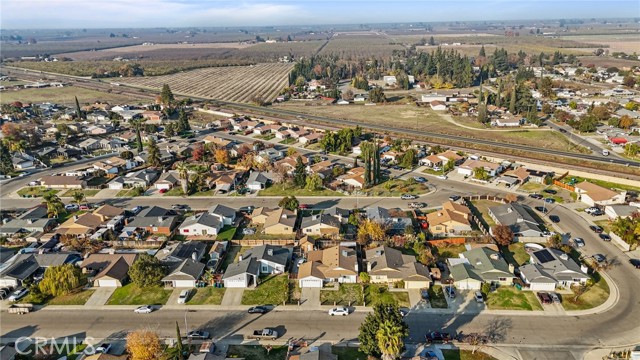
0,253,81,288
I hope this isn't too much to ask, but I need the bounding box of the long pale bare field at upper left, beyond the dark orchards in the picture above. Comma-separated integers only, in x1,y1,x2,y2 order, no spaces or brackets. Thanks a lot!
57,43,253,61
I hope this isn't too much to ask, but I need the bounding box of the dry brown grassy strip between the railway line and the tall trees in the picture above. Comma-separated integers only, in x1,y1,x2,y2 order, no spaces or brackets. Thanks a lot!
273,102,582,152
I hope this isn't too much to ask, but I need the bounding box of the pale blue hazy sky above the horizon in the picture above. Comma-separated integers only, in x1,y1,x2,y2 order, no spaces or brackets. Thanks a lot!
0,0,640,29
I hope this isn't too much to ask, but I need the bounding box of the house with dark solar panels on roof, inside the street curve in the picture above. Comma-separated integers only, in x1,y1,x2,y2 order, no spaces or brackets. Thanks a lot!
520,248,589,291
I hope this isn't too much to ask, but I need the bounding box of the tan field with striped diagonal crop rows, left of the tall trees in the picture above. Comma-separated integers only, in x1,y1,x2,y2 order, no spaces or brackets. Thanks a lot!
119,63,293,103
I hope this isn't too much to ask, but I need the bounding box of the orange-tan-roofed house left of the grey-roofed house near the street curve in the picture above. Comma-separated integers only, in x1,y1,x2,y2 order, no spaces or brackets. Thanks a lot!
427,201,472,236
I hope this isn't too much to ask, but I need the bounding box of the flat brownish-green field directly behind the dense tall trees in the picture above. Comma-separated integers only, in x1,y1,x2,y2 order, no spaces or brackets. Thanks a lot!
320,33,404,60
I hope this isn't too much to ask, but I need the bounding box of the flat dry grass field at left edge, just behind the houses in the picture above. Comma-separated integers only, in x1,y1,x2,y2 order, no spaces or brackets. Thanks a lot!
0,86,142,106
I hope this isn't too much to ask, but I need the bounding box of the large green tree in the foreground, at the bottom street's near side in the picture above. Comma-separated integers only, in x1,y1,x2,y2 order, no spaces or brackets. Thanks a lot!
358,303,409,357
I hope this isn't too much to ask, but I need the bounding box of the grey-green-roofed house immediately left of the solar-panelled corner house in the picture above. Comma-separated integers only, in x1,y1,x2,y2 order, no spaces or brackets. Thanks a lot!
448,246,514,290
